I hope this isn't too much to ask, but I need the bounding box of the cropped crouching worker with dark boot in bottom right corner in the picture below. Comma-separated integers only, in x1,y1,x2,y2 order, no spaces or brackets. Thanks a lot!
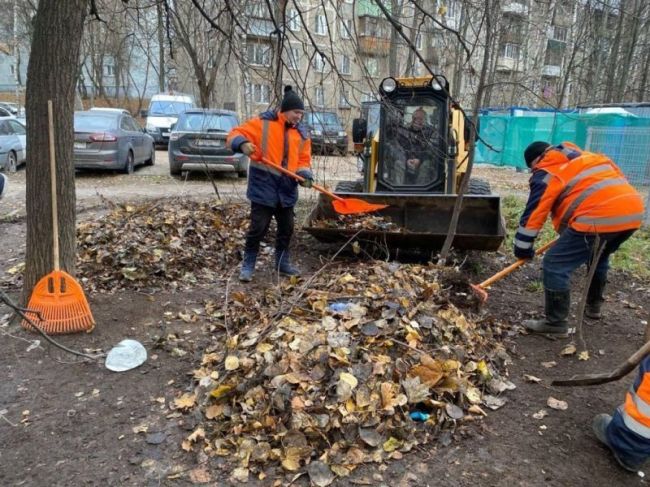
593,355,650,472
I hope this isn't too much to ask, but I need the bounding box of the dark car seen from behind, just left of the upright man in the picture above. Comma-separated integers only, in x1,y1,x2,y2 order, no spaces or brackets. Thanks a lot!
169,108,248,177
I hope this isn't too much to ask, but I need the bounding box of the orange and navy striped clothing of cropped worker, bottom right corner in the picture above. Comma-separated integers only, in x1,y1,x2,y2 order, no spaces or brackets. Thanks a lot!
607,355,650,463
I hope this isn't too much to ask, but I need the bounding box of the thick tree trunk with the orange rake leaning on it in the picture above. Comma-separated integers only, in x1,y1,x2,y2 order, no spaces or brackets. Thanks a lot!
23,0,88,301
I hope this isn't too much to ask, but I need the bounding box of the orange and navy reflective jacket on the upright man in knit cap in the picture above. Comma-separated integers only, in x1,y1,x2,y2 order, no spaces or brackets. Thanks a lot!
226,111,311,207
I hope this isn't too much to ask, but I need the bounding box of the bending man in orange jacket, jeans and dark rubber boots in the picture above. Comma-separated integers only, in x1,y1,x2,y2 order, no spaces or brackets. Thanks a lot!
514,142,643,333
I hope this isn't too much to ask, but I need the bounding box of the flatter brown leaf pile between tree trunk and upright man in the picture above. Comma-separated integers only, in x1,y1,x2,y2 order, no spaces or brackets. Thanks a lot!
77,200,248,291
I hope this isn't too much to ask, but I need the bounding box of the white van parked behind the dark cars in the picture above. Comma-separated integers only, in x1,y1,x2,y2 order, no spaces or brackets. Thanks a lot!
140,92,196,144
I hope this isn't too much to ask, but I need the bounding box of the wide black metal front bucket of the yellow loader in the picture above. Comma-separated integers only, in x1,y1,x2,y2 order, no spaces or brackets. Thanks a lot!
303,192,505,252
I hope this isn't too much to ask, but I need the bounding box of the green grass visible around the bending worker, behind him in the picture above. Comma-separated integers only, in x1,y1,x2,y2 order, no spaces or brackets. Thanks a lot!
501,195,650,280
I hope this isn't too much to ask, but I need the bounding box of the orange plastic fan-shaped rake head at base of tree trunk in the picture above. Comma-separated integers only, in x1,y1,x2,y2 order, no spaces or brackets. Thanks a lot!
22,270,95,335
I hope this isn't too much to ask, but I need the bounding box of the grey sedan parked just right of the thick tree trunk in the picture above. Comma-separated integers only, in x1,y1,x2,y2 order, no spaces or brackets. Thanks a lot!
74,109,156,174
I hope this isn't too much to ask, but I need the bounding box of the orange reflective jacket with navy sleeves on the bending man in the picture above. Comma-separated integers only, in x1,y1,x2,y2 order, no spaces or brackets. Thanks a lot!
515,142,643,254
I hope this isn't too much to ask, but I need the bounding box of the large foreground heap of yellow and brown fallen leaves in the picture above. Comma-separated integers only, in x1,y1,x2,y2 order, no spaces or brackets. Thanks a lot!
173,262,514,485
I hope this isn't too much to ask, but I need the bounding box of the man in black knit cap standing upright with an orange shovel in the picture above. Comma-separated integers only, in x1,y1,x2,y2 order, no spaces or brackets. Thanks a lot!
227,86,313,282
